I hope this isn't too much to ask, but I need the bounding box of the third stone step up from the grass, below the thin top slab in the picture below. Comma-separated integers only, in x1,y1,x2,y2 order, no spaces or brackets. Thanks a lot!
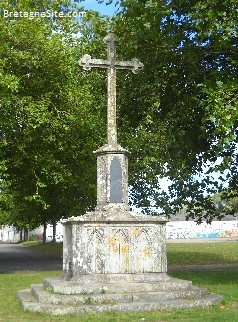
43,278,192,295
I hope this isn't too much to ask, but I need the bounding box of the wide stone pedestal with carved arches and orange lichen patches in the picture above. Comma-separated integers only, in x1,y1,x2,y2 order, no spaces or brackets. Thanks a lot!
63,209,167,280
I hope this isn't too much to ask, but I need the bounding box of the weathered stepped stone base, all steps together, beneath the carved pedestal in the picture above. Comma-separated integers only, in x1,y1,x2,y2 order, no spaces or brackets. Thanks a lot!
18,273,222,315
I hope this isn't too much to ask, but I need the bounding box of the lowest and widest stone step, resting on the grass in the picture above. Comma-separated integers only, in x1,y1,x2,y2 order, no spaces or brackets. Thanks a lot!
18,289,222,315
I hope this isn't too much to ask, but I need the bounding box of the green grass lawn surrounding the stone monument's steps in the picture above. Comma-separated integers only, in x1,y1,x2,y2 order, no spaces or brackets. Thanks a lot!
0,242,238,322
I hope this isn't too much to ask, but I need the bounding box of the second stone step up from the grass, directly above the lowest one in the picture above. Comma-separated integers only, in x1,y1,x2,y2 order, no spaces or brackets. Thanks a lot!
31,284,207,305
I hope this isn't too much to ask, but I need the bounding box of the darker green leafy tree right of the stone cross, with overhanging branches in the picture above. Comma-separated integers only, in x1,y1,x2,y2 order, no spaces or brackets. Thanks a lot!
99,0,238,222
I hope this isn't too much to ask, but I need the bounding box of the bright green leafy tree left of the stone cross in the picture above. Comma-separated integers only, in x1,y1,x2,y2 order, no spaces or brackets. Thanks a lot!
0,1,110,233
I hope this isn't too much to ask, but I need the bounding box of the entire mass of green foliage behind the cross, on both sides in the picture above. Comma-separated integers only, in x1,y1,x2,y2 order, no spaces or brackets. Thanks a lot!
0,0,238,228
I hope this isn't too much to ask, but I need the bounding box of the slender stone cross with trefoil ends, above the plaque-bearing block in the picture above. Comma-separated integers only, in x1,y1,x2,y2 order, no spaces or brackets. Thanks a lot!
79,33,144,144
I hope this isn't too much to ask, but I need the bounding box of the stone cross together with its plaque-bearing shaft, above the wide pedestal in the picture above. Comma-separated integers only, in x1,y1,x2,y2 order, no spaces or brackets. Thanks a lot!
79,33,143,210
